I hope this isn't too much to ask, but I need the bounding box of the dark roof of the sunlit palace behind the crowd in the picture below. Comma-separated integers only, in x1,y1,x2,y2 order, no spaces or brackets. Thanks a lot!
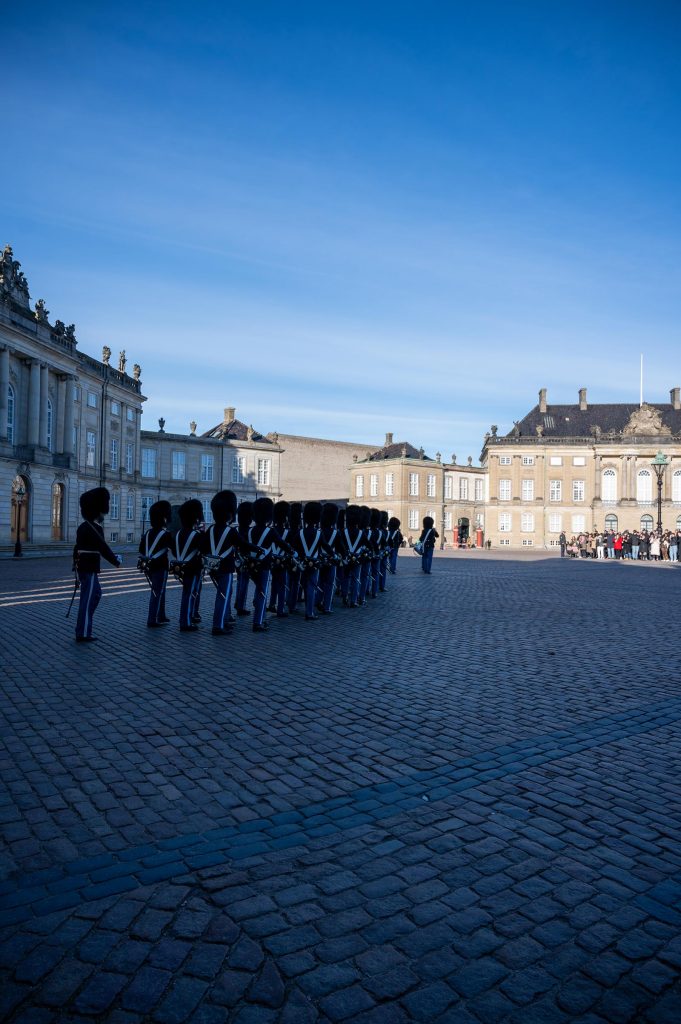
506,402,681,437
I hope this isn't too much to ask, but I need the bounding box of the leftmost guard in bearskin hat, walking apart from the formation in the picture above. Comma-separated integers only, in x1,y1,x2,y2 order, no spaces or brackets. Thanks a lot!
74,487,123,643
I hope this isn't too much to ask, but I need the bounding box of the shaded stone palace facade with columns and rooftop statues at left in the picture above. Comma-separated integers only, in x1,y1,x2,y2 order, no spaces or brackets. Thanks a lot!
0,246,144,549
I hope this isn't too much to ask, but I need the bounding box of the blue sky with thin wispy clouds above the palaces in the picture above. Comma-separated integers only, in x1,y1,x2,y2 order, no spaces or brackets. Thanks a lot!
0,0,681,460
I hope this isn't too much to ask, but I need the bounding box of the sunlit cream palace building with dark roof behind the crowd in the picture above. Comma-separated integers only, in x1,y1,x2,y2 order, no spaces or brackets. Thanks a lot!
481,387,681,548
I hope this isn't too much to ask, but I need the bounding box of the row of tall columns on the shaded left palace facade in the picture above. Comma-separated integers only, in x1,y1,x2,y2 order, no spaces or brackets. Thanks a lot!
0,347,76,455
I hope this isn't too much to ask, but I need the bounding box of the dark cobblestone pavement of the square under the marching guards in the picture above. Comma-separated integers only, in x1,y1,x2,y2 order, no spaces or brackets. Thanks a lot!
0,555,681,1024
